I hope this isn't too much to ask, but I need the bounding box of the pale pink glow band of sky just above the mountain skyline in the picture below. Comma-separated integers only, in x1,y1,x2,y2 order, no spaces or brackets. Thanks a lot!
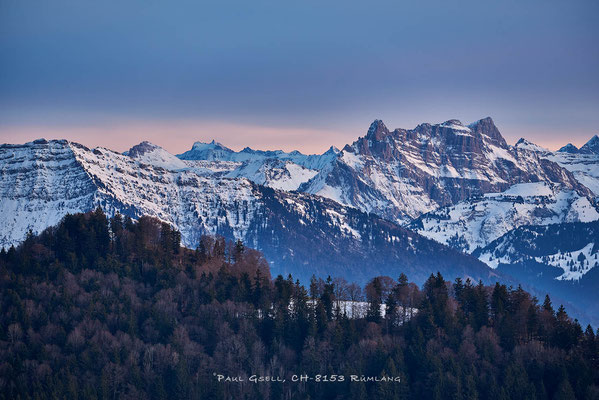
0,121,592,154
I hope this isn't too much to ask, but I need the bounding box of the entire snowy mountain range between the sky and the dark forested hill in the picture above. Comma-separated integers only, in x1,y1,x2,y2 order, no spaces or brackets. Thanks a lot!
0,118,599,324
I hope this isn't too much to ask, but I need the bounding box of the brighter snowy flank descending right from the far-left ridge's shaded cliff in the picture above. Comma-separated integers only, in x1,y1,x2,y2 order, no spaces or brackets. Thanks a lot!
68,142,264,247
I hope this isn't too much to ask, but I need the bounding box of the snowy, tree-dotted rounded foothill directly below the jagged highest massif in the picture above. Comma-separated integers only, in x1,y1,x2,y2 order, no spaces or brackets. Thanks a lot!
409,182,599,253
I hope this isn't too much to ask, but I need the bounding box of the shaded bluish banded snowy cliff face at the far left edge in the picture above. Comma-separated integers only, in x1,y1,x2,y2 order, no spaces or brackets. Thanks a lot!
0,140,98,247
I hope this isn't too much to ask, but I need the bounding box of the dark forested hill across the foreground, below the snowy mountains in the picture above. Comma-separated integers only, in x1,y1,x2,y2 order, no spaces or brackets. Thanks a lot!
0,210,599,399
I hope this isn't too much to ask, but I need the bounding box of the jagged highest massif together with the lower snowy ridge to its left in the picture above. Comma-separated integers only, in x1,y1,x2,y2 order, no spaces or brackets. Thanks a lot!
169,118,593,224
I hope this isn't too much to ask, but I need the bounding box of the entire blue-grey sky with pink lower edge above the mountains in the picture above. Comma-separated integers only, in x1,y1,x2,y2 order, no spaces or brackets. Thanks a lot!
0,0,599,153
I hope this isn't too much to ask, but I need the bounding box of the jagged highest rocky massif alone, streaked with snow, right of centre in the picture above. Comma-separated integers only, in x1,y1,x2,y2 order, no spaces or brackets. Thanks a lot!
300,118,591,223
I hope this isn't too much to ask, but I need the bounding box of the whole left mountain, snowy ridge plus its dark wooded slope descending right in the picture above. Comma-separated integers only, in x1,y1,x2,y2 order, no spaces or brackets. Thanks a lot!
0,140,496,282
